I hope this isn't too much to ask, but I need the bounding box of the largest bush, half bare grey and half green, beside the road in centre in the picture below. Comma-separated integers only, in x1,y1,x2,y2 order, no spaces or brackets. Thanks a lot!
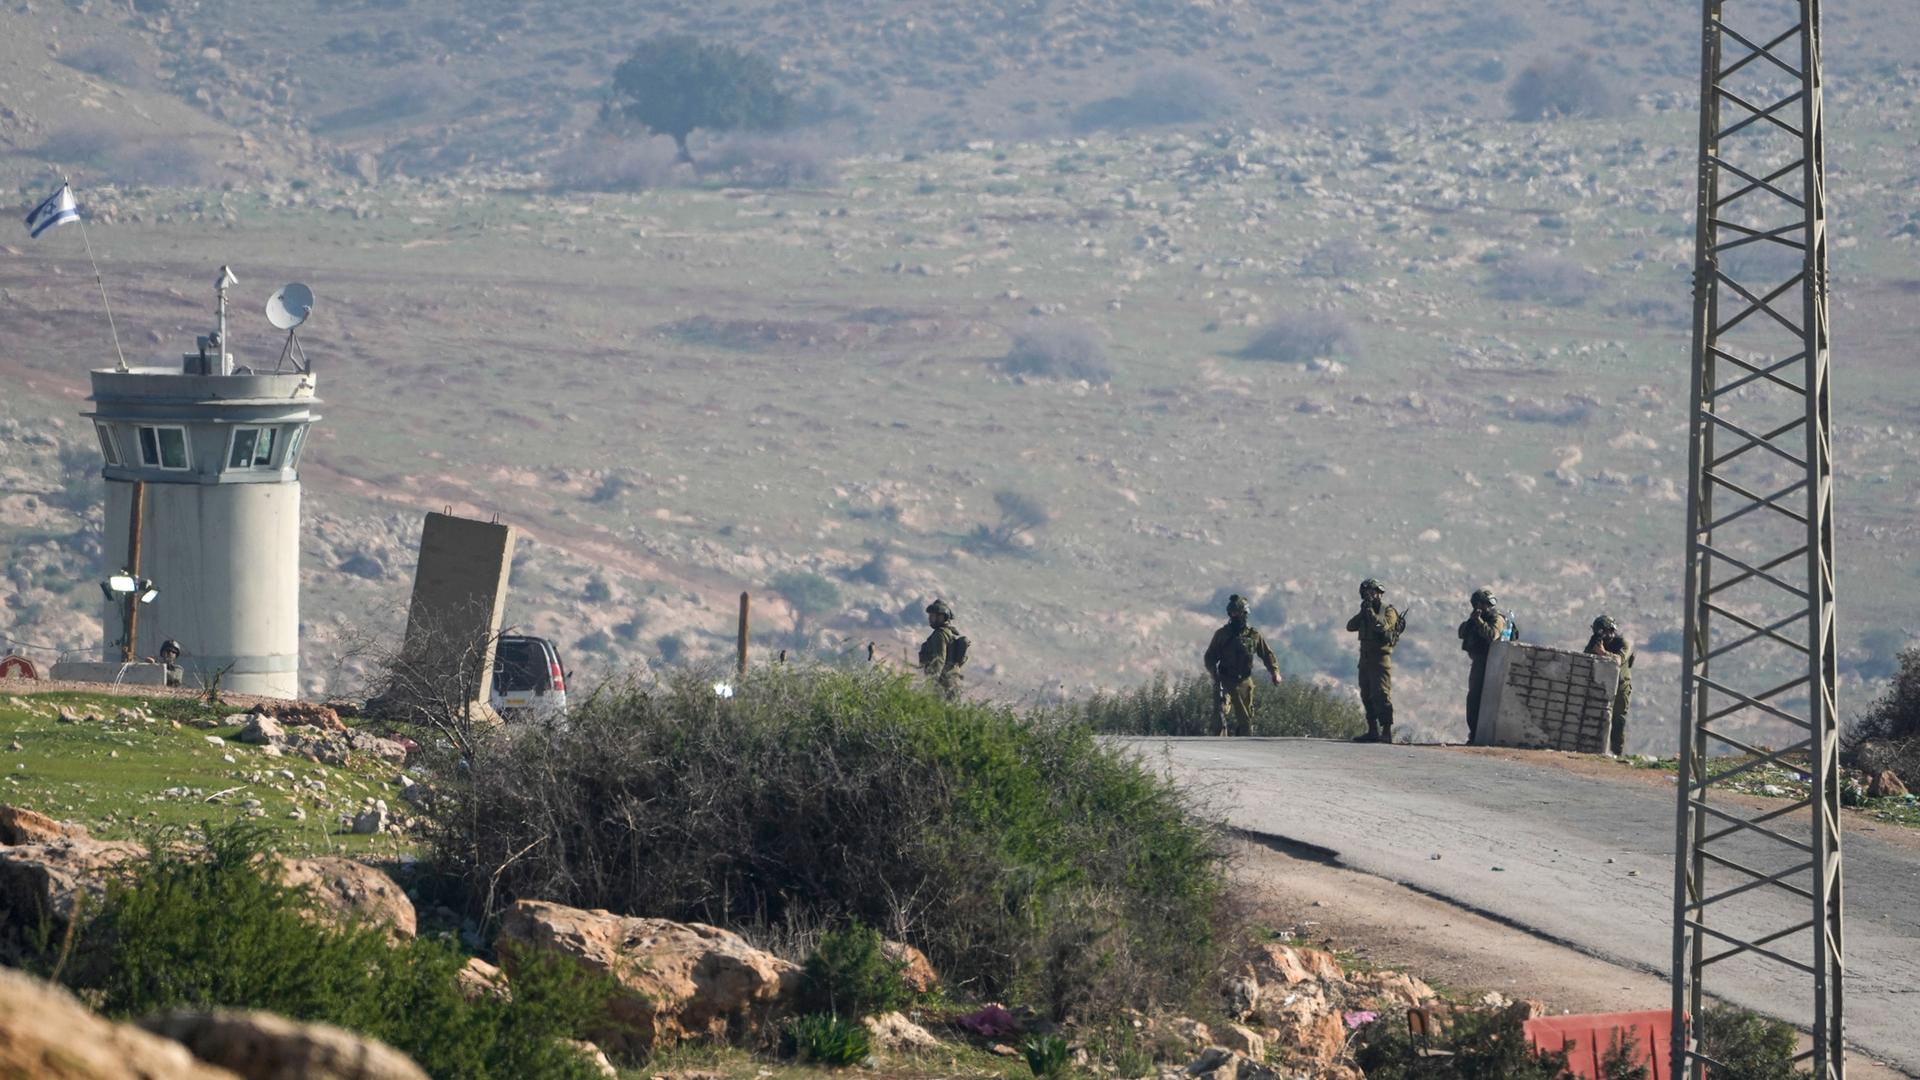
430,665,1223,1009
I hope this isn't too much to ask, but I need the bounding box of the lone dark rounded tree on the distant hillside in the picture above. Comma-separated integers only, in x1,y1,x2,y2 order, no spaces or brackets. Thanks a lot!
601,35,793,163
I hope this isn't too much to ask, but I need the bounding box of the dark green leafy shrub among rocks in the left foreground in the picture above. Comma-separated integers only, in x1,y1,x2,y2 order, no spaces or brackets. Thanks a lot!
42,824,611,1078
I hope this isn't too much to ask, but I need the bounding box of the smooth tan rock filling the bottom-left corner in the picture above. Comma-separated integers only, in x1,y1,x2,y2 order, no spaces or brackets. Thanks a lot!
0,969,238,1080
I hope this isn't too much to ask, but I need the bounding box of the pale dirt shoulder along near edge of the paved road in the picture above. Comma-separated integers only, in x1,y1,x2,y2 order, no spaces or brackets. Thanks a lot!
1235,834,1914,1080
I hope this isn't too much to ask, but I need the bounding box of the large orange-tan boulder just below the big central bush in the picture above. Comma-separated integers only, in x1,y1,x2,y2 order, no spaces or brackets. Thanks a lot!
495,899,801,1055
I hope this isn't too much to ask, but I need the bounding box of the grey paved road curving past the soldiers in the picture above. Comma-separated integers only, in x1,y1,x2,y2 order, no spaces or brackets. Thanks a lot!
1135,738,1920,1074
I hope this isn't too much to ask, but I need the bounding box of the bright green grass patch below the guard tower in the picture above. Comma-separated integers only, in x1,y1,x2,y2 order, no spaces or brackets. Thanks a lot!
0,694,407,855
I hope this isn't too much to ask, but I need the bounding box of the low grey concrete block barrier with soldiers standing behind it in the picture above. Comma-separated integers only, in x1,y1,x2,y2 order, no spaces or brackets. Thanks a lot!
1473,642,1620,753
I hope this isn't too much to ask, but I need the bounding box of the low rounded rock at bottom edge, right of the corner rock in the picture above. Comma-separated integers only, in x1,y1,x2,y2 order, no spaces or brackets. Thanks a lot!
140,1009,426,1080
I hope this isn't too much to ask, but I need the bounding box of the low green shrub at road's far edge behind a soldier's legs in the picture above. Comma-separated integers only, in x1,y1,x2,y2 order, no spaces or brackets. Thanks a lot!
1062,675,1365,738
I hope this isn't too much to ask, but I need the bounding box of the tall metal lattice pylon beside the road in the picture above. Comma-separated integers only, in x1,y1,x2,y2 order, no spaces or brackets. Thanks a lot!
1672,0,1847,1080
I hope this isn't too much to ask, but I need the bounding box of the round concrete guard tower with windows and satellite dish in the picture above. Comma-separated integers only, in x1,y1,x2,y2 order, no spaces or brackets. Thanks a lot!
83,267,321,698
